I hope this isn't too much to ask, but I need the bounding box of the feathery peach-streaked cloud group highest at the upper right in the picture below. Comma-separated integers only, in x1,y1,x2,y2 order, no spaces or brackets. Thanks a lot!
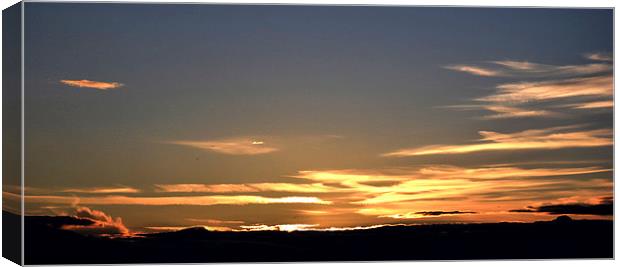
446,53,613,119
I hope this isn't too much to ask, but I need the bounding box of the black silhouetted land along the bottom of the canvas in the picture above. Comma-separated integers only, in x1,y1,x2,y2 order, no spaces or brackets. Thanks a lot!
17,216,613,264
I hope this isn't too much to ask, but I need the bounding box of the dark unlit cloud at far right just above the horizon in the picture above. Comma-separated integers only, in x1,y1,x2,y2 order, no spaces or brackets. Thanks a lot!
510,198,614,216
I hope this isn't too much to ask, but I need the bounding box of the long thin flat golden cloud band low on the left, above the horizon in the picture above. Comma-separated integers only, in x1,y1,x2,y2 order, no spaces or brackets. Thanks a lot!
26,195,331,206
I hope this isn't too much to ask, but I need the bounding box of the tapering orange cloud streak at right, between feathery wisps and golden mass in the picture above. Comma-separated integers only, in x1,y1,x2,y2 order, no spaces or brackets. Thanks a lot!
382,126,613,157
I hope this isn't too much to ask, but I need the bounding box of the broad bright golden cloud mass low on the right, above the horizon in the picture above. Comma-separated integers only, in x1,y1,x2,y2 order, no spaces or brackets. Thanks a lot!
286,165,611,210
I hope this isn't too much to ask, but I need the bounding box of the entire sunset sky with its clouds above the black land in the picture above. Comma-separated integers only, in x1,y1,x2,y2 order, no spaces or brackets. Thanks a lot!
4,3,613,234
